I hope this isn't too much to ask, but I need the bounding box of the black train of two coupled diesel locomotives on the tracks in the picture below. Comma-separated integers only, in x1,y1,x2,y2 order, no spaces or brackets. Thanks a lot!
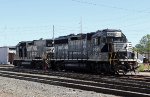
14,29,138,74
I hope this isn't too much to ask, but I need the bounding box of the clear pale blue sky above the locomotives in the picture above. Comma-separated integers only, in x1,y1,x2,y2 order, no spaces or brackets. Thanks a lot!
0,0,150,46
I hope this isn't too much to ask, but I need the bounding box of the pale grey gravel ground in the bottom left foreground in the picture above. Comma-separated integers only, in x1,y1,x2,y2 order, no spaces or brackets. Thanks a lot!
0,77,117,97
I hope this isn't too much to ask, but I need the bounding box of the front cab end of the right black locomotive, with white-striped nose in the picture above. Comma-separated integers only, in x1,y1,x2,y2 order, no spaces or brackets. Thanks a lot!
91,29,137,74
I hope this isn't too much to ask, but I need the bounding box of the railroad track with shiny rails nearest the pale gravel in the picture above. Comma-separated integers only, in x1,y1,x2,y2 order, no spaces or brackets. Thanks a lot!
0,71,150,97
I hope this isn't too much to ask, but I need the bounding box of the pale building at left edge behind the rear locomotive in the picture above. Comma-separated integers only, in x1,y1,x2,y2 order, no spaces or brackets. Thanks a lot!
0,46,16,64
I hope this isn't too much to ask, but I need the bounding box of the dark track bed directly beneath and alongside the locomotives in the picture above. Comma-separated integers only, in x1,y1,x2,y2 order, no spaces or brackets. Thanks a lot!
0,66,150,81
